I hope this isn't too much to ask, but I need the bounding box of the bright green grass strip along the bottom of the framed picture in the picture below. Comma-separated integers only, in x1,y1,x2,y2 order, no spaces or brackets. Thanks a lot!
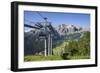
24,55,89,62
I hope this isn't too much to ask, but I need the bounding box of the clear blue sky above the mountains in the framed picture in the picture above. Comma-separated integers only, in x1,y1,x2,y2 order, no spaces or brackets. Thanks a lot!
24,11,90,28
